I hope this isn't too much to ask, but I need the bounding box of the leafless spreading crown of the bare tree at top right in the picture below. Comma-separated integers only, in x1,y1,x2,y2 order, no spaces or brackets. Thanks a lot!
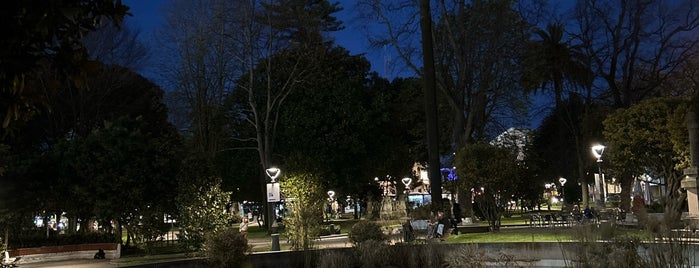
574,0,699,108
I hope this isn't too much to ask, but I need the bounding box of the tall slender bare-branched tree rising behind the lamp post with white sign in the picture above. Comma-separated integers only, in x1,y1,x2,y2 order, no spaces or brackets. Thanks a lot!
223,1,346,230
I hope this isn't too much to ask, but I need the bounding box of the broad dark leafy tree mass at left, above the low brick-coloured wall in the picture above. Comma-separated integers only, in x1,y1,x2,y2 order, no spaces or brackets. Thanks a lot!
2,63,179,241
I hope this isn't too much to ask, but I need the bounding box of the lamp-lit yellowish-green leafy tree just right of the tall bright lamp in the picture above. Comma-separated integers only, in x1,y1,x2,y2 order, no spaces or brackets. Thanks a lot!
604,98,690,226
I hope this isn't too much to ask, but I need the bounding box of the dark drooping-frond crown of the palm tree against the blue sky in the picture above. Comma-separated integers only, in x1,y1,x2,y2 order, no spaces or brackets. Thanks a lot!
522,23,592,107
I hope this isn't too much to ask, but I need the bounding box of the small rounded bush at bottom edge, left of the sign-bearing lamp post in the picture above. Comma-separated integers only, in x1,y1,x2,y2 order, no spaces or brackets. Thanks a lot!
204,228,251,267
